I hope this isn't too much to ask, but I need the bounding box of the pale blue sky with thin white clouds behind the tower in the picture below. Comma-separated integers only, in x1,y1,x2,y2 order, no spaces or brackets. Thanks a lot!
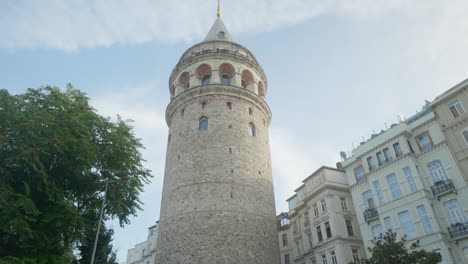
0,0,468,261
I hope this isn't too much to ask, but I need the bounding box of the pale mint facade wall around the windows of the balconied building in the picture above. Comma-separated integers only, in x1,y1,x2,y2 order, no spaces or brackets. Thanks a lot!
343,108,468,263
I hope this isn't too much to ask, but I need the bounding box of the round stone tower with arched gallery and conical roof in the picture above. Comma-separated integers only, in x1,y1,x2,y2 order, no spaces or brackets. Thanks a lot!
156,8,279,264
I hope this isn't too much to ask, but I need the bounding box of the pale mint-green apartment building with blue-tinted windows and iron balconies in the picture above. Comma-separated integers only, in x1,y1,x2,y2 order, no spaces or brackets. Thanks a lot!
343,104,468,264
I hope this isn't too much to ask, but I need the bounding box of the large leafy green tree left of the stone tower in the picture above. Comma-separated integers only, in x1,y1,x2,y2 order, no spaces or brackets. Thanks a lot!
0,85,152,264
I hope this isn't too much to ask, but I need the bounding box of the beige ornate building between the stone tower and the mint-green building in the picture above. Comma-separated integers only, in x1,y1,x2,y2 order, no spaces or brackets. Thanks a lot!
280,166,365,264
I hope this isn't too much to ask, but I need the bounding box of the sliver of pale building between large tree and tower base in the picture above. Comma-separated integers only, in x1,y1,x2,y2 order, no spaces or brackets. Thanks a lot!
127,222,158,264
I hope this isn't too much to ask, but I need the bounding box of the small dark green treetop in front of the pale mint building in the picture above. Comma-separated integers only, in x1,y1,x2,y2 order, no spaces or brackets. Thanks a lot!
349,232,442,264
